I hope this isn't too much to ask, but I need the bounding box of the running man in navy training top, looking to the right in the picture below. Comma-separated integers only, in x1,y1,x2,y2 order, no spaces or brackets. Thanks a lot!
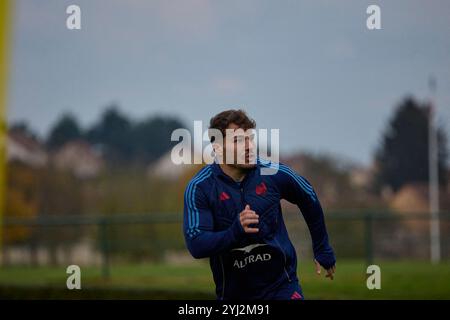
183,110,336,300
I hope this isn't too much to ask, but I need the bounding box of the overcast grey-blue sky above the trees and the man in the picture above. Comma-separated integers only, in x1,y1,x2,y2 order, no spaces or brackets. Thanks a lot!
8,0,450,164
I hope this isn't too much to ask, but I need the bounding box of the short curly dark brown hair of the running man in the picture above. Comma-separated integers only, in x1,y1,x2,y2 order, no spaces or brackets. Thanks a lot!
209,109,256,142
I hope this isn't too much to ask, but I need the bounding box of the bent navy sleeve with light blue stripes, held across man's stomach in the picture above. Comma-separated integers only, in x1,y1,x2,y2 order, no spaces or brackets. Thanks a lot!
183,183,245,259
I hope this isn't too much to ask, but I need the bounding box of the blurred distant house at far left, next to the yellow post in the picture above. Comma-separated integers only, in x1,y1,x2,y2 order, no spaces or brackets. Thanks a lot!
6,131,48,167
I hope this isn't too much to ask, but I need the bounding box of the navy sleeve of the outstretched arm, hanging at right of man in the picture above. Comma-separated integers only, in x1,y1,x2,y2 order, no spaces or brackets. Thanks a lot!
275,164,336,269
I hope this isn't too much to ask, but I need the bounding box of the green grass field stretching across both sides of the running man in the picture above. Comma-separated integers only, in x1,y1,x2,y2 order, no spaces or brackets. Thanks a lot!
0,261,450,299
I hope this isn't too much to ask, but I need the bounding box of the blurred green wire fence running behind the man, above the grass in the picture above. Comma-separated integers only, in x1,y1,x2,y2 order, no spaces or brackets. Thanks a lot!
1,212,450,277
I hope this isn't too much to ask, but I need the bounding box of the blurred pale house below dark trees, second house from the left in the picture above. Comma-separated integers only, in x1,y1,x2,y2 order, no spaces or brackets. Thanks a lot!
52,140,104,179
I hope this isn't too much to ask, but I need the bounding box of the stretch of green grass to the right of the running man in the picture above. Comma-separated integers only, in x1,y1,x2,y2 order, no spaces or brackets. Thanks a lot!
299,261,450,299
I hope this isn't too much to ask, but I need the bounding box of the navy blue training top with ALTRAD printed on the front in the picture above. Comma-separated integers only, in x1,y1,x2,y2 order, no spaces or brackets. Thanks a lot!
183,159,336,299
